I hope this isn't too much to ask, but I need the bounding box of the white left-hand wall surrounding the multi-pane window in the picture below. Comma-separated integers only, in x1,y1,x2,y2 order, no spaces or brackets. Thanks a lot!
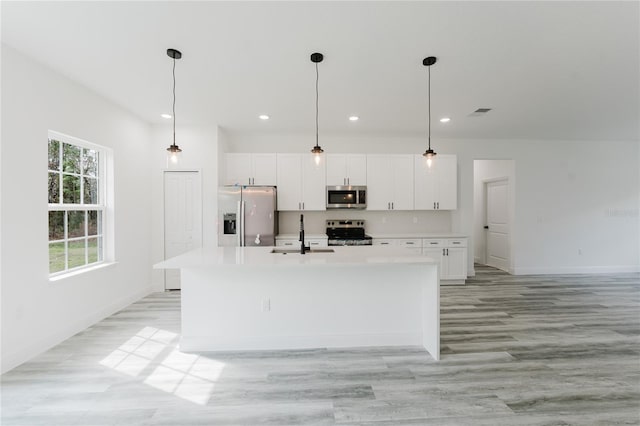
1,45,151,372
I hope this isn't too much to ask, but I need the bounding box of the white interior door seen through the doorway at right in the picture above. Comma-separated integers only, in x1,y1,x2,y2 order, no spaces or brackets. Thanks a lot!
485,179,510,271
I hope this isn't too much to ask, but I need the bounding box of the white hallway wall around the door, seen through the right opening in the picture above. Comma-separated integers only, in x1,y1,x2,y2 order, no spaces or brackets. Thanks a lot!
473,160,515,271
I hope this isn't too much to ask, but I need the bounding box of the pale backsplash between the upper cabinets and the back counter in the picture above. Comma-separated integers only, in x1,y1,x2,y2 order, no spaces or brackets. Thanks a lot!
279,210,451,234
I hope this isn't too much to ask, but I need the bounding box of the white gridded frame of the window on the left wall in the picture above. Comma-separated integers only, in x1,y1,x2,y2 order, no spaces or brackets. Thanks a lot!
47,130,112,279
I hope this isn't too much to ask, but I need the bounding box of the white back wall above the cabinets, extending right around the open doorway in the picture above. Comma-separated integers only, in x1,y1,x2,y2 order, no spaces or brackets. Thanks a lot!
228,132,640,274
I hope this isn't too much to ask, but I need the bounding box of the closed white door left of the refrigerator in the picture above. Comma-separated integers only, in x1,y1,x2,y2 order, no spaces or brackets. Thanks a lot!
164,171,202,290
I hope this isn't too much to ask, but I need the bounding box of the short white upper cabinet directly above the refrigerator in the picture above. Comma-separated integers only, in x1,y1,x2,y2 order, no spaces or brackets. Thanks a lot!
224,153,276,185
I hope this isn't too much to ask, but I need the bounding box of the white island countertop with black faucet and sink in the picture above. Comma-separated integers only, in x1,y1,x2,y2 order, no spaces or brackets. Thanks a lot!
153,246,438,269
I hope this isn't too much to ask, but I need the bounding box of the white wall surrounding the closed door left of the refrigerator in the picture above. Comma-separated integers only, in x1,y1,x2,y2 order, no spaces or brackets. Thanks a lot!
147,123,219,291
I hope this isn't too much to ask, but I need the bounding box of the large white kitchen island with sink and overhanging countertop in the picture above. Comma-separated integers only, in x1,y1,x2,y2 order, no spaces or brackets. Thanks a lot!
154,246,440,360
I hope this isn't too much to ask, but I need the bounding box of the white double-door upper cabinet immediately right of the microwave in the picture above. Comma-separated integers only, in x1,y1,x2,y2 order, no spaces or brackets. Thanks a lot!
367,154,414,210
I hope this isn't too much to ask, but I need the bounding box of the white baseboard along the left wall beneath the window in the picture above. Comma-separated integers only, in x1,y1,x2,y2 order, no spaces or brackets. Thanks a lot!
0,285,154,374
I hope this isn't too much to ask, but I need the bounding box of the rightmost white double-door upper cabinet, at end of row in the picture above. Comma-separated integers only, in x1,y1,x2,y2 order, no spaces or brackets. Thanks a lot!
414,154,458,210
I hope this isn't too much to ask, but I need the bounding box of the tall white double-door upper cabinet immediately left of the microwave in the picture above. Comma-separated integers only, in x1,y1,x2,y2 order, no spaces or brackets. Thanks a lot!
276,154,326,211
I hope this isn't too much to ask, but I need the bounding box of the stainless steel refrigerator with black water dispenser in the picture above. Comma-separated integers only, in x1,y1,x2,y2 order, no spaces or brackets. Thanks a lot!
218,186,278,247
